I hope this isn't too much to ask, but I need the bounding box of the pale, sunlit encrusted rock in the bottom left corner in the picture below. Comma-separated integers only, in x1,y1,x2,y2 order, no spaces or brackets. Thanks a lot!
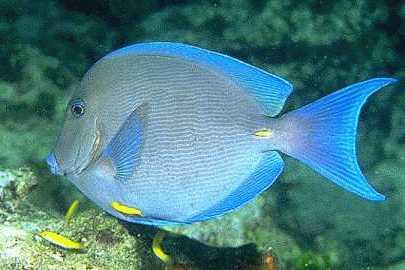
0,169,146,270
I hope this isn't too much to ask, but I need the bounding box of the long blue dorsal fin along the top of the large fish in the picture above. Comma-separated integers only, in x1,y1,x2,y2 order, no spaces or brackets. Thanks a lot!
106,42,292,116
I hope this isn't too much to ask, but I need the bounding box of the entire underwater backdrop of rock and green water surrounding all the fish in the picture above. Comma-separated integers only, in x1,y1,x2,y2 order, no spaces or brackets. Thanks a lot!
0,0,405,270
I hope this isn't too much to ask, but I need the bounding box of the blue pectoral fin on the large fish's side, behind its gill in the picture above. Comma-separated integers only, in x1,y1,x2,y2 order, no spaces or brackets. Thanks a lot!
102,104,146,181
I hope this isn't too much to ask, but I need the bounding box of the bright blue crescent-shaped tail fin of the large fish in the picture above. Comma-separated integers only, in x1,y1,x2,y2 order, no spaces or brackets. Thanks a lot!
280,78,396,201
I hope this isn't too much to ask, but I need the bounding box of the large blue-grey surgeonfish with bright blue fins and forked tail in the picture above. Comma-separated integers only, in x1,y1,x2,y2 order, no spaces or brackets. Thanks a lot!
47,42,396,226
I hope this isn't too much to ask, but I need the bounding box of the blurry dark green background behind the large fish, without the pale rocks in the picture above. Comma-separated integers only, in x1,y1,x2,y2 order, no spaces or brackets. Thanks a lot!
0,0,405,269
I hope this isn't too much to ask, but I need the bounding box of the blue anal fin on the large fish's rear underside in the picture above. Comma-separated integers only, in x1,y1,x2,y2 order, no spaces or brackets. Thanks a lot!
187,151,284,222
